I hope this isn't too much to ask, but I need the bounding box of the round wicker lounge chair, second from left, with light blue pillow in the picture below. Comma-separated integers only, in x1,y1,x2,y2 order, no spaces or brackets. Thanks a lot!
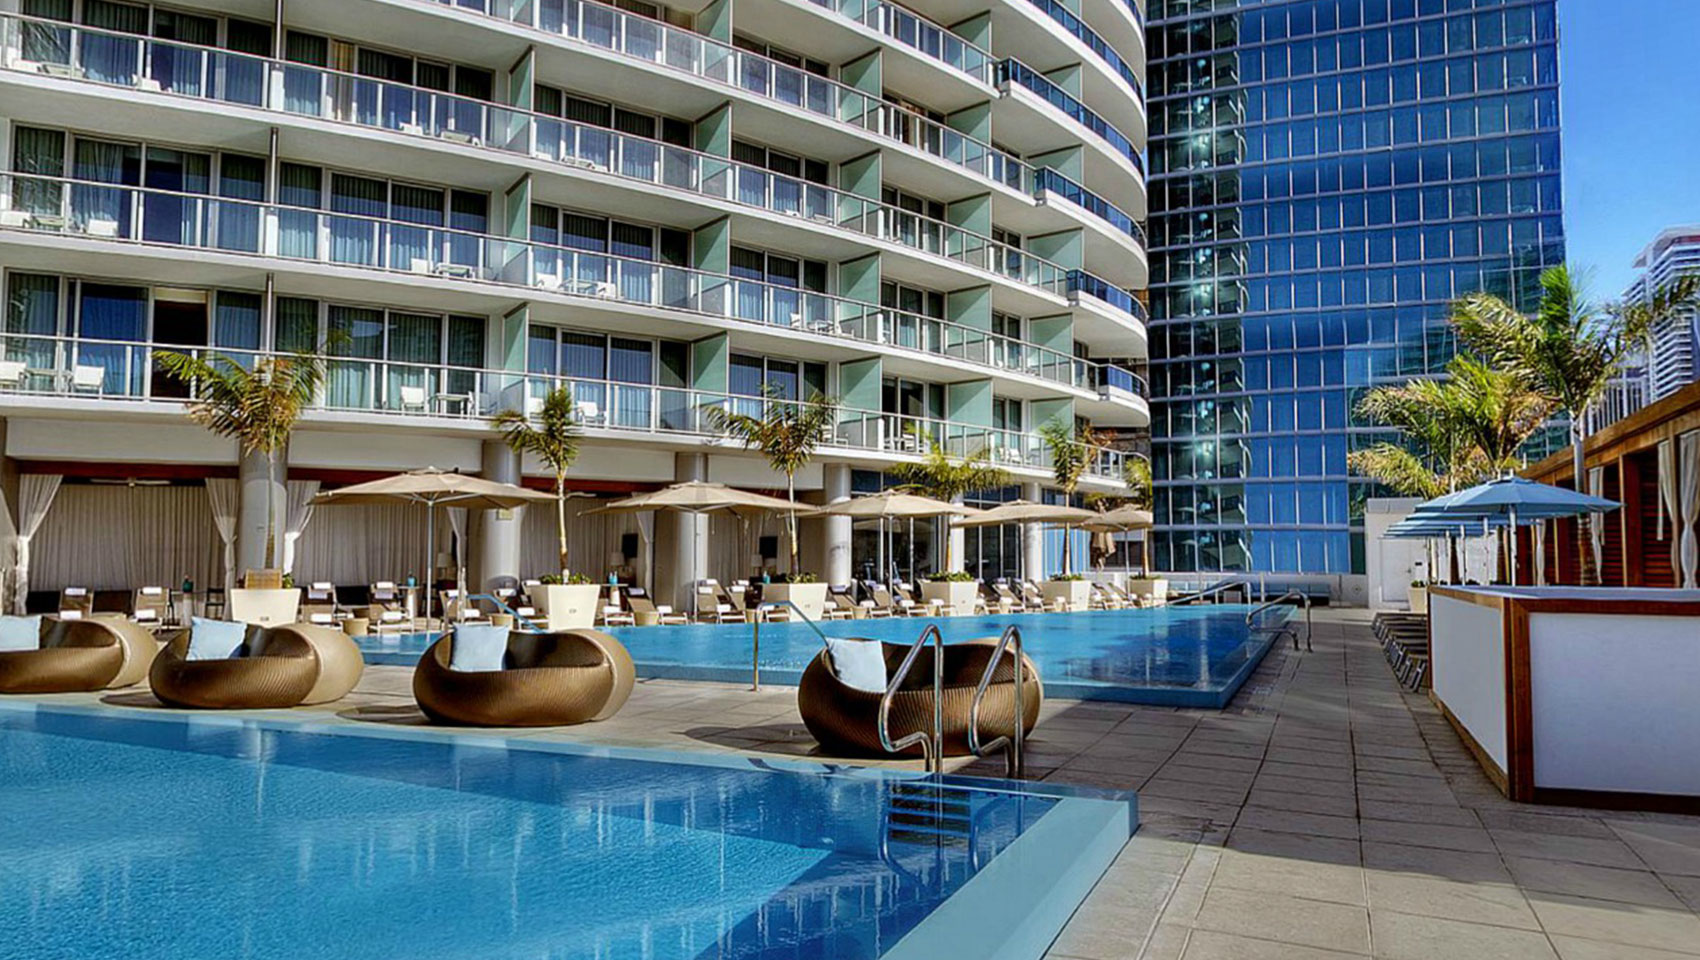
148,624,366,710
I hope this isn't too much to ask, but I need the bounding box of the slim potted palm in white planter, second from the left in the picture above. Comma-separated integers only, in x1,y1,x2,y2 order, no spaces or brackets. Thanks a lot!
490,387,602,630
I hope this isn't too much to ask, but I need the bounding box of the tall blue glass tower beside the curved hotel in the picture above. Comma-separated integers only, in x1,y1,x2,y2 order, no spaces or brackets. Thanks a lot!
1148,0,1564,574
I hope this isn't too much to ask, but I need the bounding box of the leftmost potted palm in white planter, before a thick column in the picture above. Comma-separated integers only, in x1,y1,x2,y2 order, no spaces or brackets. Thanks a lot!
155,350,325,624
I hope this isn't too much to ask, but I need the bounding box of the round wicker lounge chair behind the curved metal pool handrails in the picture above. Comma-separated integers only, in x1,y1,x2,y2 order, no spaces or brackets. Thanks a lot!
797,639,1046,756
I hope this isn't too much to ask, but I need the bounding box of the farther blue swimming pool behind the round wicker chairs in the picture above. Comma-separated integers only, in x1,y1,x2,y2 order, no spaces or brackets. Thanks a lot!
360,603,1292,709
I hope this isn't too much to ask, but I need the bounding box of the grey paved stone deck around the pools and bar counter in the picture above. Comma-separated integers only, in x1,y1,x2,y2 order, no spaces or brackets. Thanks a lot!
23,610,1700,960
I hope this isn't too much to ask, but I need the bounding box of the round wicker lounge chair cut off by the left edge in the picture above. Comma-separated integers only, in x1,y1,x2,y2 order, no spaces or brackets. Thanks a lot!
0,617,160,693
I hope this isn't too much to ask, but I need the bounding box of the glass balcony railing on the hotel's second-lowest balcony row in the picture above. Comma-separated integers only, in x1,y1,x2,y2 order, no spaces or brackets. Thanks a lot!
0,173,1142,389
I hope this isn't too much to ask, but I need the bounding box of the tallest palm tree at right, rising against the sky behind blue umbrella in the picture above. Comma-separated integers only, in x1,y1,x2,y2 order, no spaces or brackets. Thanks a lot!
1452,267,1700,581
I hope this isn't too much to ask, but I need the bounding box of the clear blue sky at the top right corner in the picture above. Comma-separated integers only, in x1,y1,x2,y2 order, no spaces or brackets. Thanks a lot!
1559,0,1700,297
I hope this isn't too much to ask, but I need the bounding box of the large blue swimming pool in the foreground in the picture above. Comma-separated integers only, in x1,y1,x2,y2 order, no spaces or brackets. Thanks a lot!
0,702,1136,960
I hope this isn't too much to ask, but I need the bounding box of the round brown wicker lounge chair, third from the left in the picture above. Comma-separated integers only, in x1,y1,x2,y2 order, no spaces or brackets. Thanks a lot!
413,630,636,727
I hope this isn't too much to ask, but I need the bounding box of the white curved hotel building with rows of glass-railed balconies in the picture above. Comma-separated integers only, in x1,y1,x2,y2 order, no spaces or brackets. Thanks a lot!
0,0,1149,601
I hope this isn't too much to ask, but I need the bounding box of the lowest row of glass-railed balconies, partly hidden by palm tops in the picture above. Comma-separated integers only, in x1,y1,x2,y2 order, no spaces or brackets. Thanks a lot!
0,333,1129,481
